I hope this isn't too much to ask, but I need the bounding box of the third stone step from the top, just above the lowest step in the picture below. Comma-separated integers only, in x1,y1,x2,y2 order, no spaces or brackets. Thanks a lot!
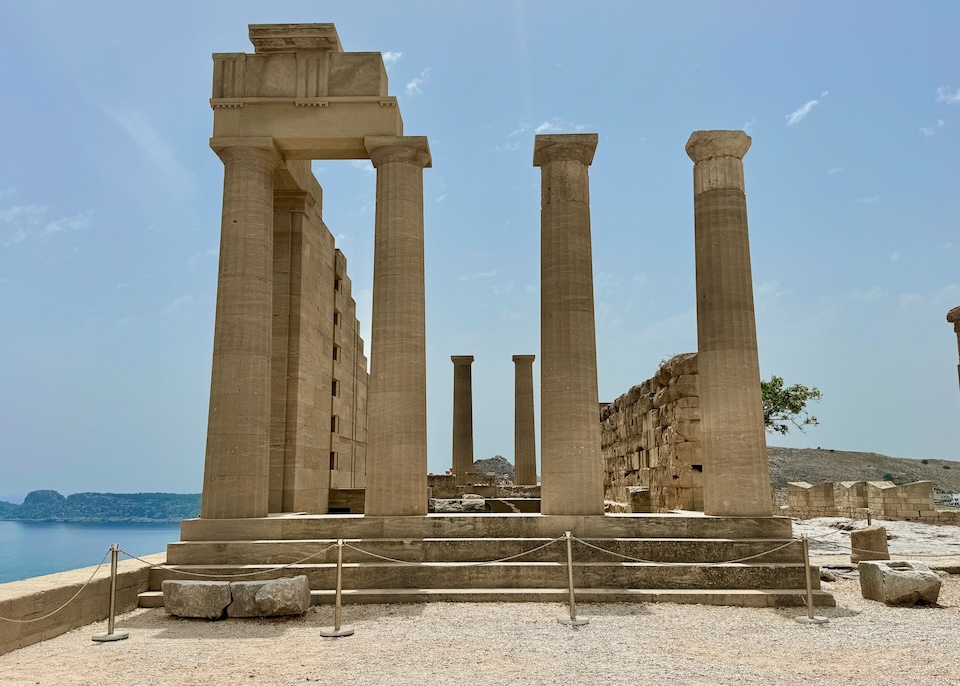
150,562,819,590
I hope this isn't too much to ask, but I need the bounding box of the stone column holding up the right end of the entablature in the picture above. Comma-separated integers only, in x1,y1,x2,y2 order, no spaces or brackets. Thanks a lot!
364,136,430,515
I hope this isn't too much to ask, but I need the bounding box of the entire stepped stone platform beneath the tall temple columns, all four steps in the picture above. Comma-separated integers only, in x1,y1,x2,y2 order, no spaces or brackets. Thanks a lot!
140,512,833,606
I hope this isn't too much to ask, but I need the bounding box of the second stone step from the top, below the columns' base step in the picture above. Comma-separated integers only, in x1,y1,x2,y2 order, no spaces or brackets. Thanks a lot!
167,538,803,565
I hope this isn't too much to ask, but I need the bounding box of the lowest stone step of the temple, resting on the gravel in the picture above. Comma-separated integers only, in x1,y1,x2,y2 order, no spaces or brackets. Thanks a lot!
139,588,836,612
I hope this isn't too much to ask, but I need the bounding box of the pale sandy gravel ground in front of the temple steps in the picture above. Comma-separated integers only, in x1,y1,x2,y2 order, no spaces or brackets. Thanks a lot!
0,520,960,686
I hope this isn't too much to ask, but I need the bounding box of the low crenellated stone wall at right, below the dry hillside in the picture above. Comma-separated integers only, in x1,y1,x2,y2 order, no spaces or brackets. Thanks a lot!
782,481,960,525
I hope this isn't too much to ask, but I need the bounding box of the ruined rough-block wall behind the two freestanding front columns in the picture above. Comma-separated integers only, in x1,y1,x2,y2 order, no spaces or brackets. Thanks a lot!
600,353,703,512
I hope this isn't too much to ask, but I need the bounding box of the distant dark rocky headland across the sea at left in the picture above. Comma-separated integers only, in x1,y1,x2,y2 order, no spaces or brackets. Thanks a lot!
0,491,200,522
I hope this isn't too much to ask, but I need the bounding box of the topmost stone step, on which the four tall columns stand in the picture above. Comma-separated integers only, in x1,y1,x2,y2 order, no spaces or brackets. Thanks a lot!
180,512,792,541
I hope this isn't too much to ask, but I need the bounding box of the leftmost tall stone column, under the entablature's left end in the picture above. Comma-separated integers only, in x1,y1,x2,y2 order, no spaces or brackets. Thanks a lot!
200,139,280,519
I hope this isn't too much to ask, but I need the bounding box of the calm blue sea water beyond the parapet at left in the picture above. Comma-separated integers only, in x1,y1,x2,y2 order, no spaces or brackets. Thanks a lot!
0,521,180,583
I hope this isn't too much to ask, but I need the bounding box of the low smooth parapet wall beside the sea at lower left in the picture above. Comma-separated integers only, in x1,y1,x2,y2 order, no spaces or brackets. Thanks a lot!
0,553,166,655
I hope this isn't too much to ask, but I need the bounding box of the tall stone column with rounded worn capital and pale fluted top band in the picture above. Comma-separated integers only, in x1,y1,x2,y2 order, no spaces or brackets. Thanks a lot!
686,131,773,517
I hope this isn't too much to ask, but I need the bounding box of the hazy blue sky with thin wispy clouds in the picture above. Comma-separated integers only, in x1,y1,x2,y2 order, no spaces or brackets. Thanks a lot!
0,0,960,502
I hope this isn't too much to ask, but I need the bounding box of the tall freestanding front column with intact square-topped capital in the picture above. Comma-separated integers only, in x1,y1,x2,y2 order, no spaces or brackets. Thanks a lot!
533,134,603,515
